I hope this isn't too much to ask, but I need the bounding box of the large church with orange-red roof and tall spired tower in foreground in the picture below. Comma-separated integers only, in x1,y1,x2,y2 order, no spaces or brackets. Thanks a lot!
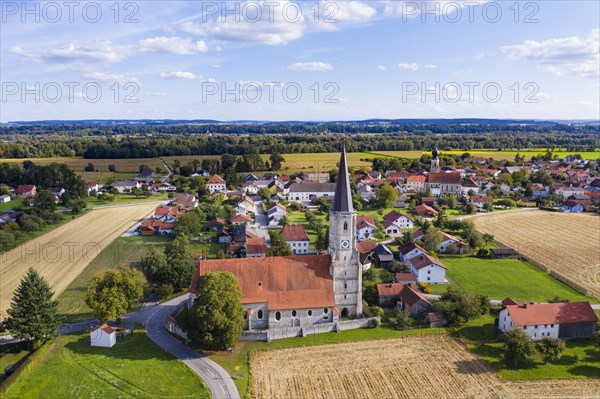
189,148,362,331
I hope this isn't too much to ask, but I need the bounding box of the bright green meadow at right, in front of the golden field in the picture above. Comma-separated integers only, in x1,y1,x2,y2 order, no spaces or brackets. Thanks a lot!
440,255,598,303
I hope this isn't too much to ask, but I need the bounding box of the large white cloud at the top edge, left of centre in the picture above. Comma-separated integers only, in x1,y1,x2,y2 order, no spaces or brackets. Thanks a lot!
180,0,306,46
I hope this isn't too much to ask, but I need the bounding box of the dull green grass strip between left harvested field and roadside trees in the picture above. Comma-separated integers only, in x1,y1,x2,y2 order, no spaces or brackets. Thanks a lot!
58,236,170,324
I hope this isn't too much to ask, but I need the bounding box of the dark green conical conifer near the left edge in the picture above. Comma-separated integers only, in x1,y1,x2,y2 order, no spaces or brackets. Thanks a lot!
7,268,61,349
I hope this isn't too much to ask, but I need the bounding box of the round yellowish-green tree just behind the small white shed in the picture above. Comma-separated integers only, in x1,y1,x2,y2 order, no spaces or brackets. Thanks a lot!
85,268,144,323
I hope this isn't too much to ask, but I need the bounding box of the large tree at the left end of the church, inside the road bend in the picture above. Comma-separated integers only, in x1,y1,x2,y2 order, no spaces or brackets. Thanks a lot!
187,272,244,349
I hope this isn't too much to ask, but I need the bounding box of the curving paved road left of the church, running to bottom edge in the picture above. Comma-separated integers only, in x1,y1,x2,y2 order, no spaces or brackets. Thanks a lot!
145,295,240,399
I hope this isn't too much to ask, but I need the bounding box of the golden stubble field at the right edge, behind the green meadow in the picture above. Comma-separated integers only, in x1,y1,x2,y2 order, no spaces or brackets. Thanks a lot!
474,210,600,298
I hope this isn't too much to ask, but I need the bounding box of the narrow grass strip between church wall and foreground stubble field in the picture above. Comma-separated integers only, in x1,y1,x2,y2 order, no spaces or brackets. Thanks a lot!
203,324,446,398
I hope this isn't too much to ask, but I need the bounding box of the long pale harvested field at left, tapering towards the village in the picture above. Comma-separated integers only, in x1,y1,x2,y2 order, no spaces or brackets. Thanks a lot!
0,203,156,315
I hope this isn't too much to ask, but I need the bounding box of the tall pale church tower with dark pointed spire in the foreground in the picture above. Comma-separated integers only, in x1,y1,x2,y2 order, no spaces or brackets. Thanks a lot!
329,146,362,317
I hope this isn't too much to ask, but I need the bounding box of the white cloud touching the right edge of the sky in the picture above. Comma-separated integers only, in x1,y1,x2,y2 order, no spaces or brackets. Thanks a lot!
502,29,600,78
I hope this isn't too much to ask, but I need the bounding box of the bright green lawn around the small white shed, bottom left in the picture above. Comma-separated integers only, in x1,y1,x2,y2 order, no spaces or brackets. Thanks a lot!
3,330,210,399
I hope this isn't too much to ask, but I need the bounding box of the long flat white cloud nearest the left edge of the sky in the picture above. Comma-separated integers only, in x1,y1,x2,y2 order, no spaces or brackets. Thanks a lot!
10,41,132,63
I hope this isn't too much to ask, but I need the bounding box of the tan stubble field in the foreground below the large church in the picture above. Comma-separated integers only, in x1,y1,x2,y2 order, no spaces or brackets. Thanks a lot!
251,335,600,399
